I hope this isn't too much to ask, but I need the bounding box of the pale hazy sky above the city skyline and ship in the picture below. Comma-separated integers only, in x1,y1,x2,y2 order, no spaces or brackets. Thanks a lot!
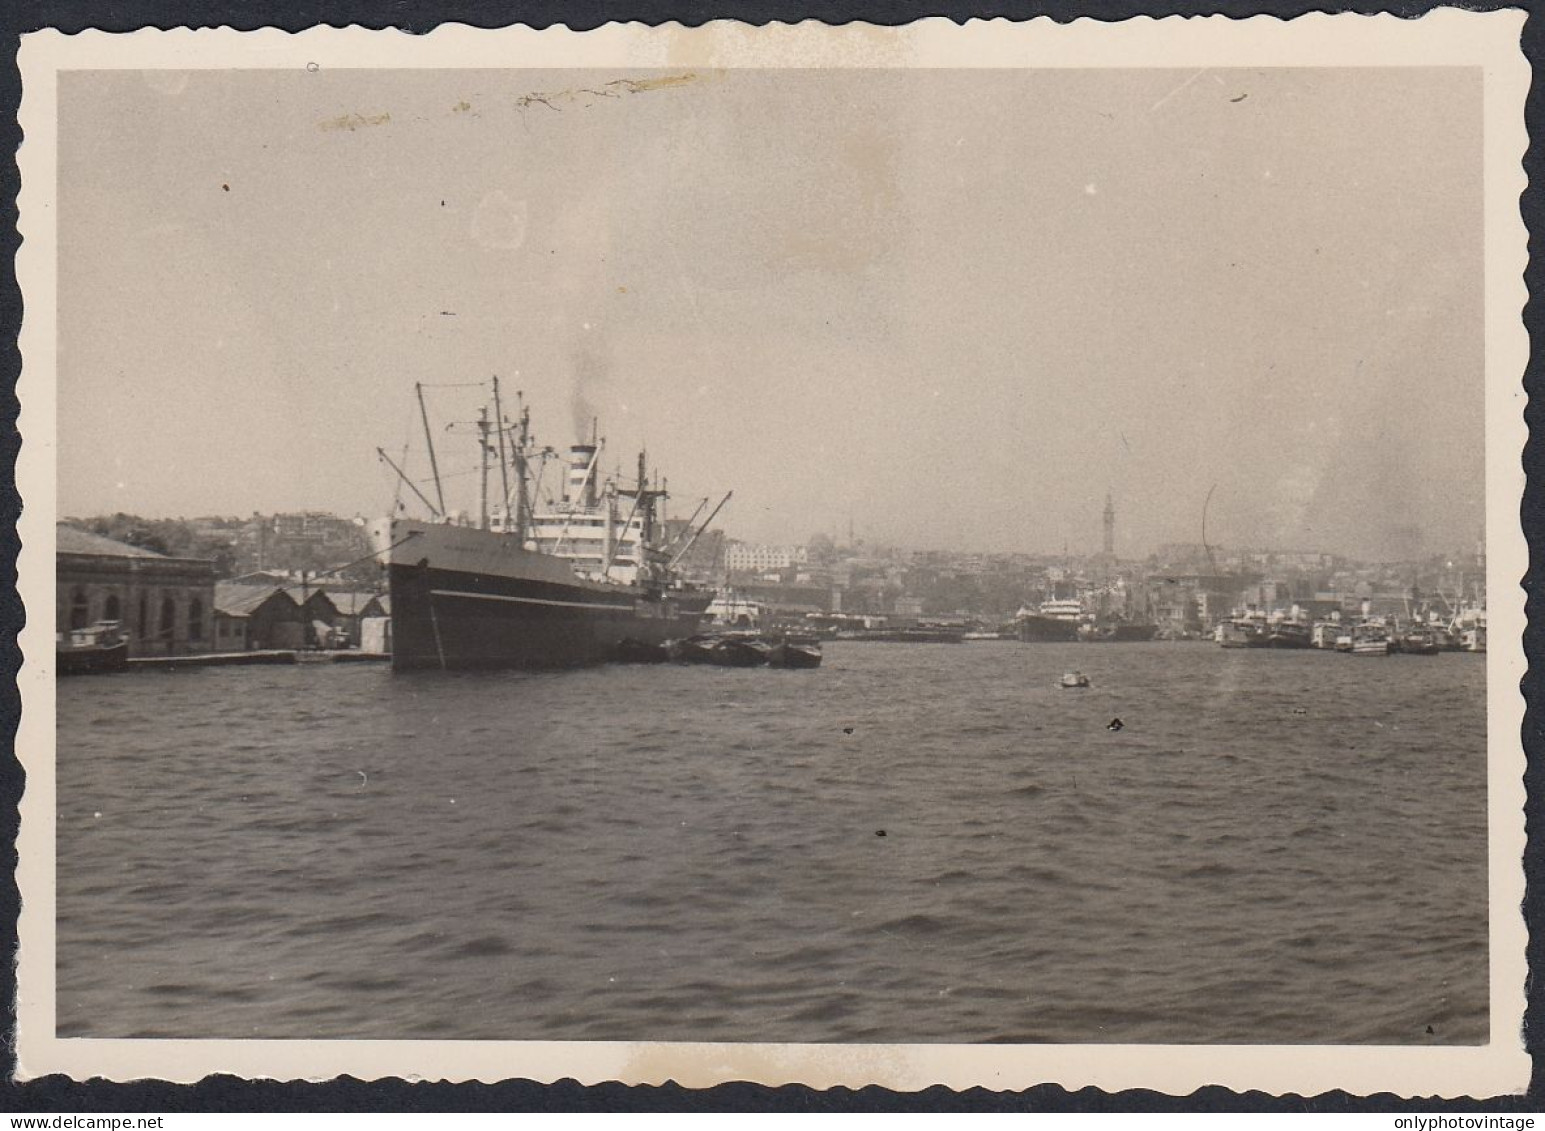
59,68,1483,558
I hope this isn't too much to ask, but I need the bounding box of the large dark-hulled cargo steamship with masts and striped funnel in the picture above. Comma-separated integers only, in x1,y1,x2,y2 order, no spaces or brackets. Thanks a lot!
371,383,713,671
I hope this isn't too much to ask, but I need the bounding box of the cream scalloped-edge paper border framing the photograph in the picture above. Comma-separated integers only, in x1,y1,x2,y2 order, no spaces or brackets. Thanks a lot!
17,9,1531,1097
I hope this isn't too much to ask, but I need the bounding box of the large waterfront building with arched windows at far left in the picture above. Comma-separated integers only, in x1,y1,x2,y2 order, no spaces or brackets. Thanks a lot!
54,522,215,657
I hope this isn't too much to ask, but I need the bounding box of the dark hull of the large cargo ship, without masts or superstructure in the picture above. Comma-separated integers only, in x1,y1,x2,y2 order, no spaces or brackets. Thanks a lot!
383,521,709,671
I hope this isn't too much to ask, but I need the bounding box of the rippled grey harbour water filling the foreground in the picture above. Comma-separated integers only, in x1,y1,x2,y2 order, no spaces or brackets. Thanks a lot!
57,641,1488,1044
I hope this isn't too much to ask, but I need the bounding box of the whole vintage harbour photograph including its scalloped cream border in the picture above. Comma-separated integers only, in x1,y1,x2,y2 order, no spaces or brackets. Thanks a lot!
22,12,1528,1094
